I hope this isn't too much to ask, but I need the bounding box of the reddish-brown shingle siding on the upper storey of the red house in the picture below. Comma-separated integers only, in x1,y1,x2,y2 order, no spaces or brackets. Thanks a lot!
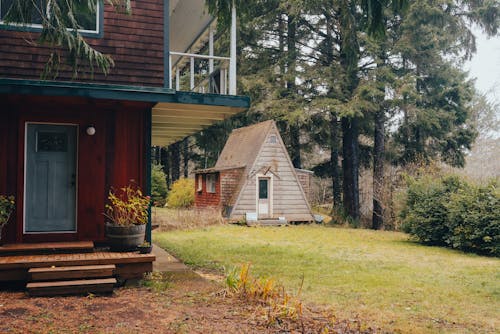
0,0,163,86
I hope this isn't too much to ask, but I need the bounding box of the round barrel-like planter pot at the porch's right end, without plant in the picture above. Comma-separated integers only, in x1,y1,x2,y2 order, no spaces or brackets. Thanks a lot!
106,223,146,252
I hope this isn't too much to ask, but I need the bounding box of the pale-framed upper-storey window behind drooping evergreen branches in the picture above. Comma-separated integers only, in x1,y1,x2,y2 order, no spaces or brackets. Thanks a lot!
0,0,103,35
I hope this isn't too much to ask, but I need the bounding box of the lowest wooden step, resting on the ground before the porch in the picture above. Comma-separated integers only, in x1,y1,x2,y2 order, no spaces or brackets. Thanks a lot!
26,277,116,296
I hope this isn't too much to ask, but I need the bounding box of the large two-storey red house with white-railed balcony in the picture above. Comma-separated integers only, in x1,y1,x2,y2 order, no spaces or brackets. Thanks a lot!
0,0,249,290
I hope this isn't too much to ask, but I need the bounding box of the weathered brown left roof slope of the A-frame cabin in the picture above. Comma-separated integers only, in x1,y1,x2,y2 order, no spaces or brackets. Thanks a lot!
214,120,274,169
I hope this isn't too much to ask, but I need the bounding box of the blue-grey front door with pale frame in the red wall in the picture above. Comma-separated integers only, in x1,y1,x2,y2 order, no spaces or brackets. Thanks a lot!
24,123,78,233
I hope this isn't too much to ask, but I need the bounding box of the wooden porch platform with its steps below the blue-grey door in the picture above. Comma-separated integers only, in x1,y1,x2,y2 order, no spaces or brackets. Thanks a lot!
0,242,155,295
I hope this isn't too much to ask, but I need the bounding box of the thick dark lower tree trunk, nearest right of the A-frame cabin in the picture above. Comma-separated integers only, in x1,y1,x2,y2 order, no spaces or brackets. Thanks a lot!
342,117,360,220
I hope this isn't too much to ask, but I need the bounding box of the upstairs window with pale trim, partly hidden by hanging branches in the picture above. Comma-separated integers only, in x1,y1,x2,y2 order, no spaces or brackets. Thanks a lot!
0,0,103,37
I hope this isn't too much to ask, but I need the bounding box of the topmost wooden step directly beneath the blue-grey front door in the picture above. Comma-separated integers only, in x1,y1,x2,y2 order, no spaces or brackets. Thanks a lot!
0,241,94,256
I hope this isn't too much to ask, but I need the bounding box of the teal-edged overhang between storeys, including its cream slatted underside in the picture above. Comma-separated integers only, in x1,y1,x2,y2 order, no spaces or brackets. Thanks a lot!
0,78,250,146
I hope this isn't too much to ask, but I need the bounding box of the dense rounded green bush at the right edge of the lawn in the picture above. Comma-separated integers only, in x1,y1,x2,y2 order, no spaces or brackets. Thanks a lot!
401,176,500,256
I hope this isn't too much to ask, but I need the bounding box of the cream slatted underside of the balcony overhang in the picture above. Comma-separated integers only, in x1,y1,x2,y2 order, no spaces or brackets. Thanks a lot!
151,102,246,146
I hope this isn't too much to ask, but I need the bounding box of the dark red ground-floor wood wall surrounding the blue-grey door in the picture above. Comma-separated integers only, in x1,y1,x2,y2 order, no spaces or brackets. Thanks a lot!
0,95,152,242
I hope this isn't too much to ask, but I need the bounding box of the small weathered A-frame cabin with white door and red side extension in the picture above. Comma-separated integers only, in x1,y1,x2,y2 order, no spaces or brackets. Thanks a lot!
195,120,314,222
